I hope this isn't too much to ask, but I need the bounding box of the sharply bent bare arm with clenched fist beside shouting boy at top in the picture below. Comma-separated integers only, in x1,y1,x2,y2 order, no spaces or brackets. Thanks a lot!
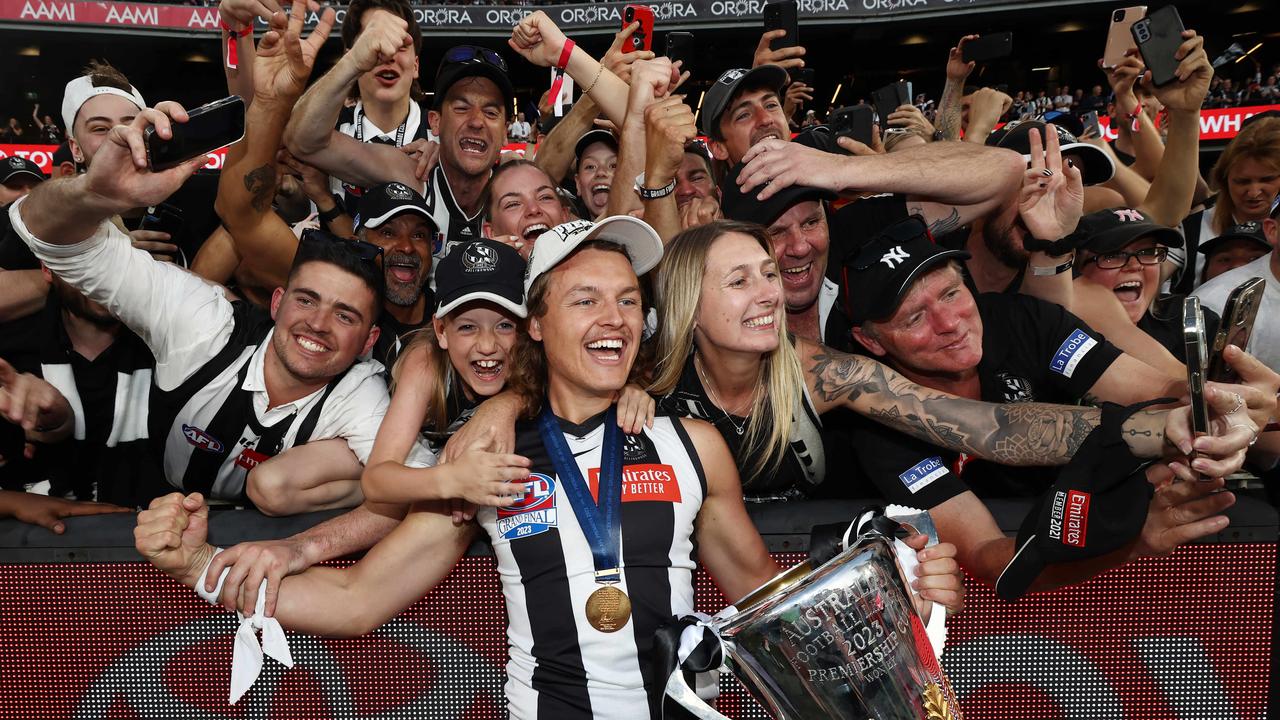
284,12,422,188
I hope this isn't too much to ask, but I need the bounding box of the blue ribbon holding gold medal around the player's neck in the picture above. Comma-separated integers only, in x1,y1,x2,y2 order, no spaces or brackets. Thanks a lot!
538,400,622,584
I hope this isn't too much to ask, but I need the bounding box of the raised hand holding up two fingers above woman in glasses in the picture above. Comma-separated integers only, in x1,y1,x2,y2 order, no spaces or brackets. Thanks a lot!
1018,126,1084,244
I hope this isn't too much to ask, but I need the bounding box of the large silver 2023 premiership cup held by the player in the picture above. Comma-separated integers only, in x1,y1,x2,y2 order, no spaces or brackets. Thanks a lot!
712,533,960,720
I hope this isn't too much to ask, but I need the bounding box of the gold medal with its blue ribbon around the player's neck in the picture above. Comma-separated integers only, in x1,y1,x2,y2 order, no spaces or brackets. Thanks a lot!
538,400,631,633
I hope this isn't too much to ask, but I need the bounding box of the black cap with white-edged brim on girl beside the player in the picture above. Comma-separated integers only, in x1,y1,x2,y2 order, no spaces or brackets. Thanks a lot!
435,238,527,318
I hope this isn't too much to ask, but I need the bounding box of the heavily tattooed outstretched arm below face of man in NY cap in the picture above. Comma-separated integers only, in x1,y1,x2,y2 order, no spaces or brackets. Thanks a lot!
809,347,1101,465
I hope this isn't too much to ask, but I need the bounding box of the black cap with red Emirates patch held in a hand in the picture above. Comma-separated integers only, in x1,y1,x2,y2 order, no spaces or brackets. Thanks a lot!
996,404,1152,602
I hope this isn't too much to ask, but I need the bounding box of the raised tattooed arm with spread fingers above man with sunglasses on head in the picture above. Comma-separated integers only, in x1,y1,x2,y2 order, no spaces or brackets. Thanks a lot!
214,3,334,286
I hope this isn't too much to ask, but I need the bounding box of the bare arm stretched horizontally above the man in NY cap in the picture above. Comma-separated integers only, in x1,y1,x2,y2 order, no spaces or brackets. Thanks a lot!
739,133,1027,234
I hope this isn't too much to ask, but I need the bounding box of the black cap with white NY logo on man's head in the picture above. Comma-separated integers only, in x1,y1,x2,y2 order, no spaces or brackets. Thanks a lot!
841,215,969,327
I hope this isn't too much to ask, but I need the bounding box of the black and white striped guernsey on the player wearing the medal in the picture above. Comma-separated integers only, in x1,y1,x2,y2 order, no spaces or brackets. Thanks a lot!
477,414,707,720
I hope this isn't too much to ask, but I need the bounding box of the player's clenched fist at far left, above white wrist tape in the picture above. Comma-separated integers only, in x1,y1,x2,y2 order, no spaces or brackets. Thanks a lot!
133,492,214,588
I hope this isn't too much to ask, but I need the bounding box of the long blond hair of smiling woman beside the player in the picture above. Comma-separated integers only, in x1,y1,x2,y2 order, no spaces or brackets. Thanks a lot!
649,220,805,478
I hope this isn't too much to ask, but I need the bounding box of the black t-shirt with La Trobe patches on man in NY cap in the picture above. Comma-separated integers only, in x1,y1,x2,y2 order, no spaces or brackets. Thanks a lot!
854,288,1120,509
